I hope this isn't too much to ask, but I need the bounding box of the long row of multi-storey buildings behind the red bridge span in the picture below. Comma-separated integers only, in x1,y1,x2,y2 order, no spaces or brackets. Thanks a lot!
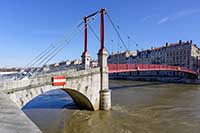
108,40,200,72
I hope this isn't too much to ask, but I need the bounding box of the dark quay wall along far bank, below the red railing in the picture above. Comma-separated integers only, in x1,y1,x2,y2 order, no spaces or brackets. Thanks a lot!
109,71,200,84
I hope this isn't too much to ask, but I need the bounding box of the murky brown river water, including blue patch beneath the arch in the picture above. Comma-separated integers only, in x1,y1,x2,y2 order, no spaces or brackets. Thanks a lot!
23,80,200,133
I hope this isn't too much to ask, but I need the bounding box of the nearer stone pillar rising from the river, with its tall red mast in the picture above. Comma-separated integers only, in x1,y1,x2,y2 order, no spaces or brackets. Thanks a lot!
98,9,111,110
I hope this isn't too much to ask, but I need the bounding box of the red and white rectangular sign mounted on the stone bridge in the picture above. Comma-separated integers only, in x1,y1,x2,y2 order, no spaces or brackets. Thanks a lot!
52,76,66,86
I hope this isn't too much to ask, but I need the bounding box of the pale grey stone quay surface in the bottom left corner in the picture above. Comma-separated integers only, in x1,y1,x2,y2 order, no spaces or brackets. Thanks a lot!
0,91,41,133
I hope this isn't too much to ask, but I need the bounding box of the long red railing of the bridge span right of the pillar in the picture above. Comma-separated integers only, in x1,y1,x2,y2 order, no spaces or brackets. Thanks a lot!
108,64,197,75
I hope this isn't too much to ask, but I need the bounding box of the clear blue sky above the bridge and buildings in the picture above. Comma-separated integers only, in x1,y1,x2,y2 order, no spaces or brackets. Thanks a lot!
0,0,200,67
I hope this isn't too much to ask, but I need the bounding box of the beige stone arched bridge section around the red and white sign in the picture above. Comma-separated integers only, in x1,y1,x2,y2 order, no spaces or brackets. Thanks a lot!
0,67,108,110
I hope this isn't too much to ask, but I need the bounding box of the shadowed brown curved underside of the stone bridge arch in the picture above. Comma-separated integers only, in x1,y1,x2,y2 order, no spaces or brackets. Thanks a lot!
62,88,95,110
